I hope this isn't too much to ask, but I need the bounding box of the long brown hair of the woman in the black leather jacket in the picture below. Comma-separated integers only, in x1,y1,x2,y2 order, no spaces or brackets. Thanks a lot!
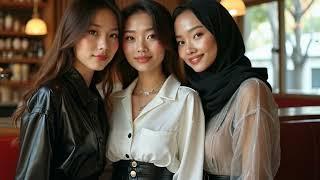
12,0,121,125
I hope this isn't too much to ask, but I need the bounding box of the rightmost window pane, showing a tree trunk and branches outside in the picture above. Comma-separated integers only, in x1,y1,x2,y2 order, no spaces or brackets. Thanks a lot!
285,0,320,94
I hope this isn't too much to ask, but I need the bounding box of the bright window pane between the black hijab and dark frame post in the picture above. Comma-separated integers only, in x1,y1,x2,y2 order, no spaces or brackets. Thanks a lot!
243,1,279,91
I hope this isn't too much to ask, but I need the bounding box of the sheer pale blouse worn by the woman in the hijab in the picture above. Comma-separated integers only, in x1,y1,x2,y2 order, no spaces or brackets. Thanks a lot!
204,78,280,180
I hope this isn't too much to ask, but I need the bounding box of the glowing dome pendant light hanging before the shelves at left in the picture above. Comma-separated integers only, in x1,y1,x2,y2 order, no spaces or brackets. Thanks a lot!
25,0,47,36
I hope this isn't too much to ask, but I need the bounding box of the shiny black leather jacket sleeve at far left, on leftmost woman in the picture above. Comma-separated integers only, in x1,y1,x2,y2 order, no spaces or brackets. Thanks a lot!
15,88,55,180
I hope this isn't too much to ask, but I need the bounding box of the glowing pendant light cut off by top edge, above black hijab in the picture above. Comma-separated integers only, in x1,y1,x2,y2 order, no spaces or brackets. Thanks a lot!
220,0,246,17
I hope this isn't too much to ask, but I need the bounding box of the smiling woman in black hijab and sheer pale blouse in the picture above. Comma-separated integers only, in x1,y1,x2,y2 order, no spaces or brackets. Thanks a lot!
173,0,280,180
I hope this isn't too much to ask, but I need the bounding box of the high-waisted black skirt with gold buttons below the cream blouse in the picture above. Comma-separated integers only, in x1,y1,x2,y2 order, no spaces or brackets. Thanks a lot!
112,160,173,180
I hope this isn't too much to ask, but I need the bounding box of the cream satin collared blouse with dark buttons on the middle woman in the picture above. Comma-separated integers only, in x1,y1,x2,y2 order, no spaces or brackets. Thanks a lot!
107,75,205,180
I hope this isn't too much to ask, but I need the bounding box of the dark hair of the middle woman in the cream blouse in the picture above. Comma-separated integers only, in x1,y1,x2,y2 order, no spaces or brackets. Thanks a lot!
118,0,184,88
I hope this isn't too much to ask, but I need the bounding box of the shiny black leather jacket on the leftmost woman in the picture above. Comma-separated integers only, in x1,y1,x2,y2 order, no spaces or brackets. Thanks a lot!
16,69,109,180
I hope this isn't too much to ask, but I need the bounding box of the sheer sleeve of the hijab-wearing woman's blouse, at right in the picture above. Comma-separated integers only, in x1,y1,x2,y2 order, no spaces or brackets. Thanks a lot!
231,80,280,180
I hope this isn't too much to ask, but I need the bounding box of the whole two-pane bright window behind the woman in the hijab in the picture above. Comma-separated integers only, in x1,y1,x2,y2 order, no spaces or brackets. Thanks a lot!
243,0,320,94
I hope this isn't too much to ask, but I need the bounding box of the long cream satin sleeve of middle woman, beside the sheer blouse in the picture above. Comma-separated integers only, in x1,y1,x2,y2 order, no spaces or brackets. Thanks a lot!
173,92,205,180
